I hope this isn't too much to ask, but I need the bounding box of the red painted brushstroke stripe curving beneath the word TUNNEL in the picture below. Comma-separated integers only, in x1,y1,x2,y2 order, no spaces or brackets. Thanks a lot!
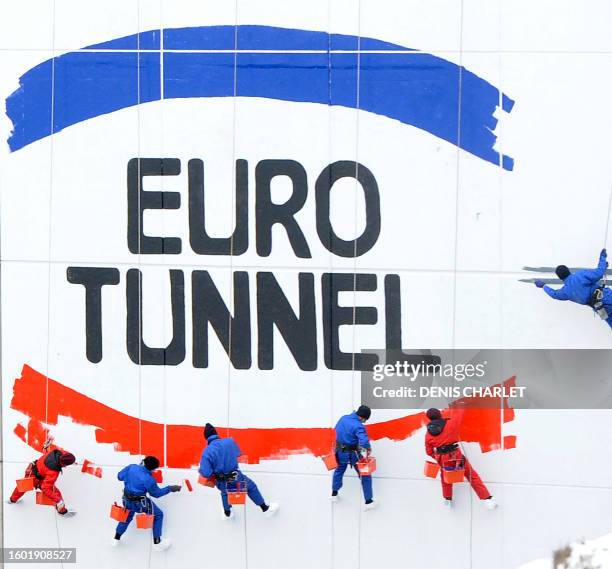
11,365,514,468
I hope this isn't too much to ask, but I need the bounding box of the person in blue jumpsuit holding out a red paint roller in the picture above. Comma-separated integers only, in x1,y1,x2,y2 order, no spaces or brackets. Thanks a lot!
112,456,181,551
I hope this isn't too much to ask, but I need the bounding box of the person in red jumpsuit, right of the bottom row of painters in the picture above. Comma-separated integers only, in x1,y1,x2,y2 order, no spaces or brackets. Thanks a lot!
425,408,497,510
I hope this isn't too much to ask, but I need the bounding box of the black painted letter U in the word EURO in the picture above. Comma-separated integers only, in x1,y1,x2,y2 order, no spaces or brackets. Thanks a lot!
187,158,249,255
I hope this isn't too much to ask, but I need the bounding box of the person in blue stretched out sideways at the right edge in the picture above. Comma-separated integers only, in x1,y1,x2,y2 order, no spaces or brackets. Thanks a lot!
535,249,612,327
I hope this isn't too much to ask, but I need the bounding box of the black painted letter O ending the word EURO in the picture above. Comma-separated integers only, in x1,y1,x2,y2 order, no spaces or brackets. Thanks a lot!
315,160,380,257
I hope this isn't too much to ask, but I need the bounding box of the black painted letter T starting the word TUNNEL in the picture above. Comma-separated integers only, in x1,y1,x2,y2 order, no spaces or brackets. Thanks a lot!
66,267,119,364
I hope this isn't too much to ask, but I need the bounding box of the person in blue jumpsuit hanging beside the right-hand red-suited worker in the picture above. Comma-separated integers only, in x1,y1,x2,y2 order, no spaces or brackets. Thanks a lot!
331,405,378,510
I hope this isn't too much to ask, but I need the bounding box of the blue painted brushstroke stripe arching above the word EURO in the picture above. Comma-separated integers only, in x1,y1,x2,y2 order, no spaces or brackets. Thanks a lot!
6,26,514,170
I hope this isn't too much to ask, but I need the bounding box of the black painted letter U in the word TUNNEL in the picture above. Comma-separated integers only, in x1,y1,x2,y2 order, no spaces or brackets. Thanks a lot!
126,269,185,365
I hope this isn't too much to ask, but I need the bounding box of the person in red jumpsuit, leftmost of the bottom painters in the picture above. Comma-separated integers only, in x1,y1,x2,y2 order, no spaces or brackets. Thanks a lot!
8,448,76,518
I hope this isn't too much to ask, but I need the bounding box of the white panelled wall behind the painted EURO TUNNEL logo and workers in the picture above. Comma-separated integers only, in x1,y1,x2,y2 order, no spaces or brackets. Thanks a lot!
0,0,612,569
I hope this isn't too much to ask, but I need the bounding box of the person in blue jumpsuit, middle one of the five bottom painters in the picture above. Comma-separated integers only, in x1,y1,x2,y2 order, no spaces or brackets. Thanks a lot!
198,423,280,520
